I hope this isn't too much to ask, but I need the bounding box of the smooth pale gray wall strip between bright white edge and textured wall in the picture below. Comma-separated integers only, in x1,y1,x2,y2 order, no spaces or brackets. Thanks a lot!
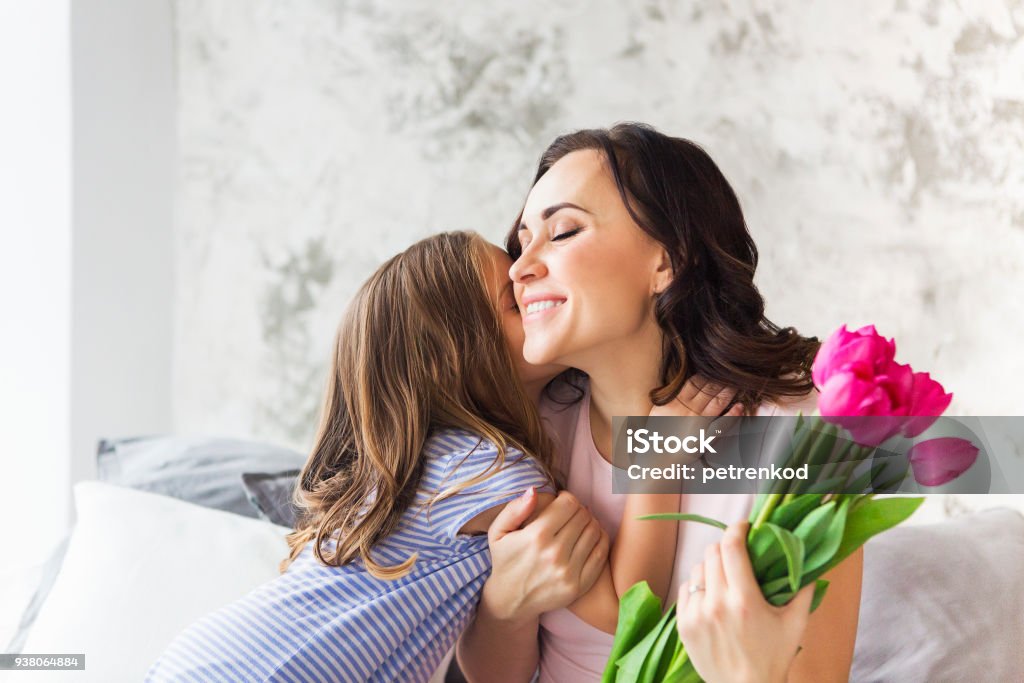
70,0,176,501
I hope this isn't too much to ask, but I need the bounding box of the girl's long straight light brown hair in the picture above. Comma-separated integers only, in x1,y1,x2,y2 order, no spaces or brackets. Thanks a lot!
280,232,554,579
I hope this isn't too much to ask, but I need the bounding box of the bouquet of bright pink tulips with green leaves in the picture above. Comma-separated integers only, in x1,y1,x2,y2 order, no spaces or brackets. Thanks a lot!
601,326,978,683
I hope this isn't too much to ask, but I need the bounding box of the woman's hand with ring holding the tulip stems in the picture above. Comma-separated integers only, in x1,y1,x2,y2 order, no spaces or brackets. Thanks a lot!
676,521,814,683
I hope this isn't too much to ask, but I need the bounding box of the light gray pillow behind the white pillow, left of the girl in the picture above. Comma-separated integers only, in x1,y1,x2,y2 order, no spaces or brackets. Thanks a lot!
96,436,306,517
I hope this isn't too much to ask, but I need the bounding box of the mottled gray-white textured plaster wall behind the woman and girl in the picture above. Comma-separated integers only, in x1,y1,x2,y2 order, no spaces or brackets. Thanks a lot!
174,5,1024,456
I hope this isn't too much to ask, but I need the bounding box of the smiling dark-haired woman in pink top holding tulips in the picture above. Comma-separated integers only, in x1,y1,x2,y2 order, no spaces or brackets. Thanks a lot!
459,124,862,683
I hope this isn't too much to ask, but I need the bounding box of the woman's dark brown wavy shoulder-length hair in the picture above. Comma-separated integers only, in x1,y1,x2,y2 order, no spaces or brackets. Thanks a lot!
505,123,820,413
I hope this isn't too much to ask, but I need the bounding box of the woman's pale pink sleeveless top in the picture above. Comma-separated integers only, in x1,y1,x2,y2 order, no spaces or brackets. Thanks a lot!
540,382,817,683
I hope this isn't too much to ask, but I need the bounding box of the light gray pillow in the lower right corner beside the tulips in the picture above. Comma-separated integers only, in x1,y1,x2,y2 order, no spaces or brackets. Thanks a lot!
850,508,1024,683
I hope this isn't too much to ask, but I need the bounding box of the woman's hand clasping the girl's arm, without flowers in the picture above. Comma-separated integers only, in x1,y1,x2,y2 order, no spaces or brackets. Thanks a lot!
481,489,608,623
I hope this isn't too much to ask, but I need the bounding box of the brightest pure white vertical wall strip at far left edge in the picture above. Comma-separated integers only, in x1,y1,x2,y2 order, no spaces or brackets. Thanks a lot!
0,0,72,647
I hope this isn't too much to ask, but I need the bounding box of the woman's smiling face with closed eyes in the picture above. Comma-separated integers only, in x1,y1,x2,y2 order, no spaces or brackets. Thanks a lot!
509,150,672,372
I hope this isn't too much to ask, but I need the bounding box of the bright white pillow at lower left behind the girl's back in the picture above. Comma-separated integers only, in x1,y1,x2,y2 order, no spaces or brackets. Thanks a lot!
4,481,290,683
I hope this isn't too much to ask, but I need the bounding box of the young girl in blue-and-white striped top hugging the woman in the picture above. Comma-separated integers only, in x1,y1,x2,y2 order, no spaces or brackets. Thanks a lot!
146,232,729,683
